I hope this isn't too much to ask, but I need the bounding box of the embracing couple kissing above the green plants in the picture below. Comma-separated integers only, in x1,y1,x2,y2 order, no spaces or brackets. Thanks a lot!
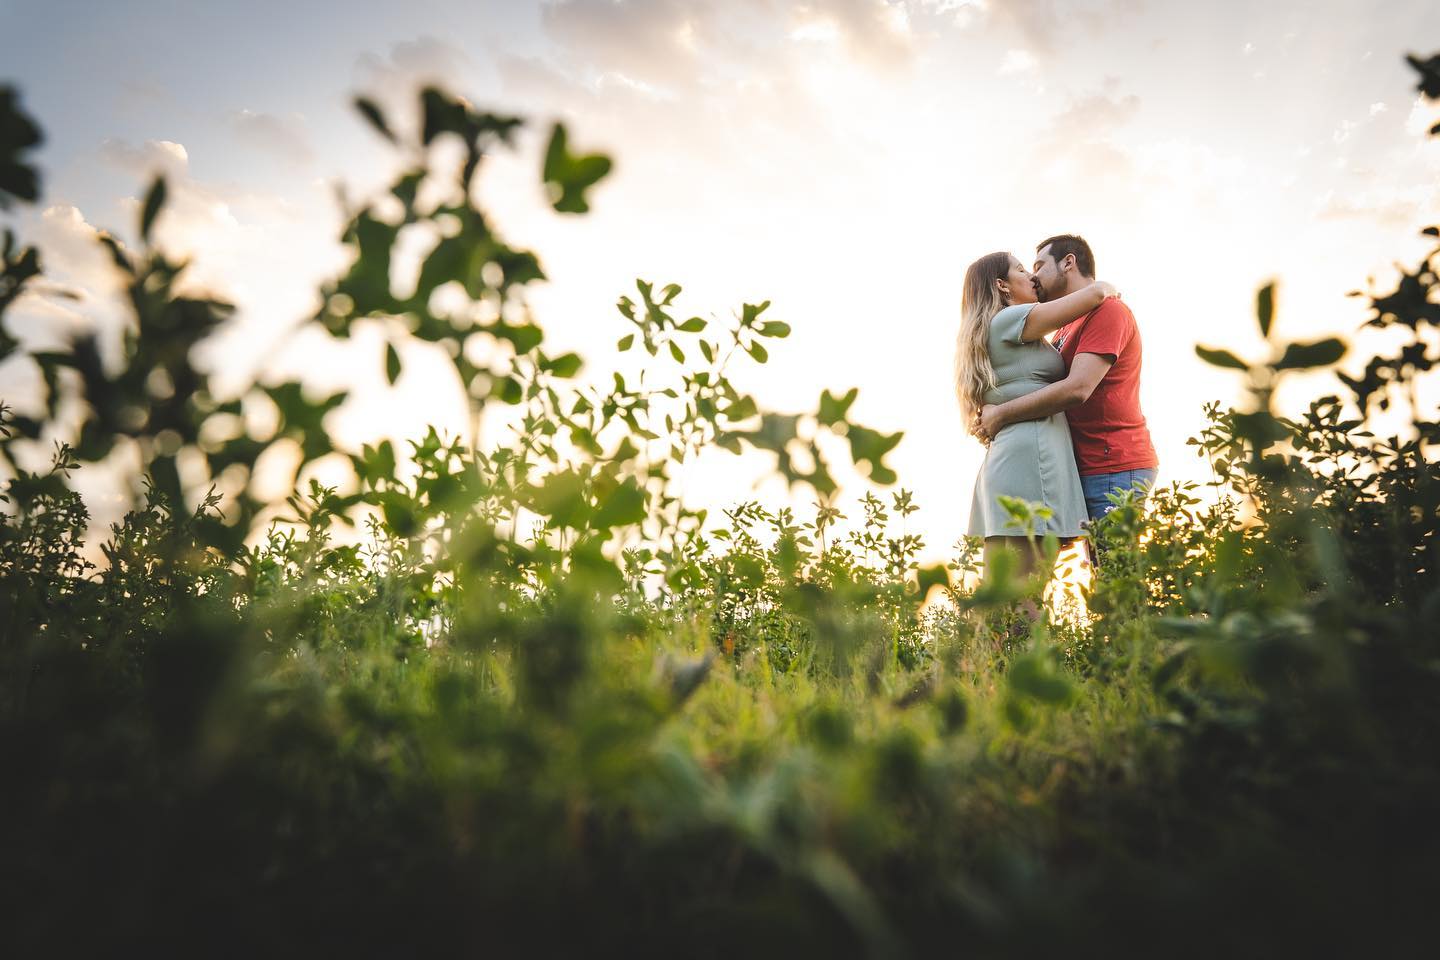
955,233,1159,590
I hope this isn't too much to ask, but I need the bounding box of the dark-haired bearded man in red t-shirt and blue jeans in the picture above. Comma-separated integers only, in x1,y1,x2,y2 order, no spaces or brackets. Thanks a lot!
976,233,1159,522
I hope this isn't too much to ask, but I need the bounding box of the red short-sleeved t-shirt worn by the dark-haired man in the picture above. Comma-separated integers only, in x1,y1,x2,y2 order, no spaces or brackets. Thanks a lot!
1053,296,1159,476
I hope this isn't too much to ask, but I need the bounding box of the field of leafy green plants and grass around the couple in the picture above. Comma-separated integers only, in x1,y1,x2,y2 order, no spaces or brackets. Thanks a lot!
0,55,1440,957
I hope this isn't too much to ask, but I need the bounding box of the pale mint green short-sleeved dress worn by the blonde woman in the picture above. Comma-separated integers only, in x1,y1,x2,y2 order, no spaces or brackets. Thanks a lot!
969,304,1089,537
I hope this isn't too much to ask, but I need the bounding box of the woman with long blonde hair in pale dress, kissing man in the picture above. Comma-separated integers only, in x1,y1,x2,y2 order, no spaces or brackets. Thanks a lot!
955,252,1117,592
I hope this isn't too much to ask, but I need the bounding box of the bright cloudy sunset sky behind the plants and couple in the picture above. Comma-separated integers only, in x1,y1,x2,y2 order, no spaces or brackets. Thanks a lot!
0,0,1440,558
